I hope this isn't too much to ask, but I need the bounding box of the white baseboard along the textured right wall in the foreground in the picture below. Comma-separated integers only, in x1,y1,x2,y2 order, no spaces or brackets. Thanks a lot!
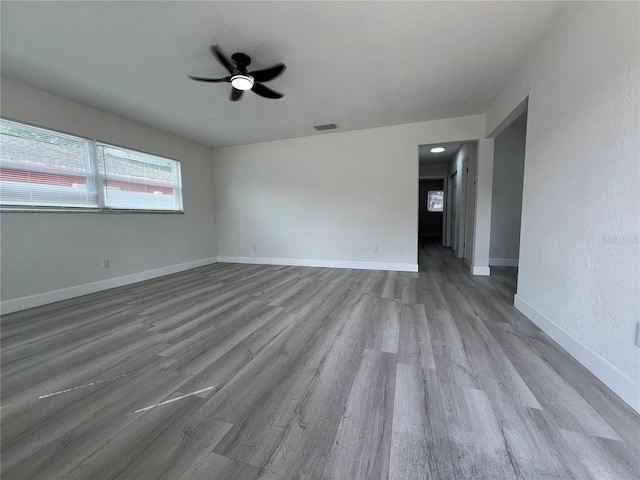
513,294,640,413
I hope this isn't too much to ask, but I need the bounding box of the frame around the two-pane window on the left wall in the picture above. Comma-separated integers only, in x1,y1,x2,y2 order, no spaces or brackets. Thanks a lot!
0,116,184,215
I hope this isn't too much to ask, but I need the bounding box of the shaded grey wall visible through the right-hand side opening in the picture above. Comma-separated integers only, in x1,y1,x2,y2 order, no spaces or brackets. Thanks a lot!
489,113,527,267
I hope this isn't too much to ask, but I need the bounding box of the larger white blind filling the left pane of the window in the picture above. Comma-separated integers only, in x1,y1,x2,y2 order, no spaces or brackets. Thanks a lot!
0,119,98,208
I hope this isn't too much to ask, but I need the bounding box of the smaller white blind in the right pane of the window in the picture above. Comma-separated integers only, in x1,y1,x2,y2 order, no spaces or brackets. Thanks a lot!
96,143,182,210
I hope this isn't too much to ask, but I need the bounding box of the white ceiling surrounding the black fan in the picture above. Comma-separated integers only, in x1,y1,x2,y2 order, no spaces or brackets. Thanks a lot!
0,1,561,147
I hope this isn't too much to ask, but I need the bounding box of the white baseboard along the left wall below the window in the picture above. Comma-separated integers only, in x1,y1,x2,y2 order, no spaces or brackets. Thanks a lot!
0,257,218,315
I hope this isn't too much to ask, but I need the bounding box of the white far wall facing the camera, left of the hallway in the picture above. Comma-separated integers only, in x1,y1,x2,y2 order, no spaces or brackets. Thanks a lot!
213,115,493,270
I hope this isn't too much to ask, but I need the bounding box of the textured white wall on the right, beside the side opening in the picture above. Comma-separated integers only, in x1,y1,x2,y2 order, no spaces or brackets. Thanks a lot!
487,2,640,410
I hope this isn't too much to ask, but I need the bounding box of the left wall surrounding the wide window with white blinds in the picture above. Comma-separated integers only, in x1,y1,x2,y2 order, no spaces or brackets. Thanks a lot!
1,78,217,313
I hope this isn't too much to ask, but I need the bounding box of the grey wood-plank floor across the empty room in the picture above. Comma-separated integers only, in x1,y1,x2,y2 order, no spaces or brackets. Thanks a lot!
0,242,640,480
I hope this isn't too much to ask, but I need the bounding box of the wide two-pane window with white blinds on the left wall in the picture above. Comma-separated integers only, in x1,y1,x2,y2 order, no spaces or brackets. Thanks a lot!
0,119,182,212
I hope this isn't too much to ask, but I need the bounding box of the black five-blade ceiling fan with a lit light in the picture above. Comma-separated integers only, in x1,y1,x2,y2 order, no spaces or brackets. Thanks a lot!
188,45,287,102
